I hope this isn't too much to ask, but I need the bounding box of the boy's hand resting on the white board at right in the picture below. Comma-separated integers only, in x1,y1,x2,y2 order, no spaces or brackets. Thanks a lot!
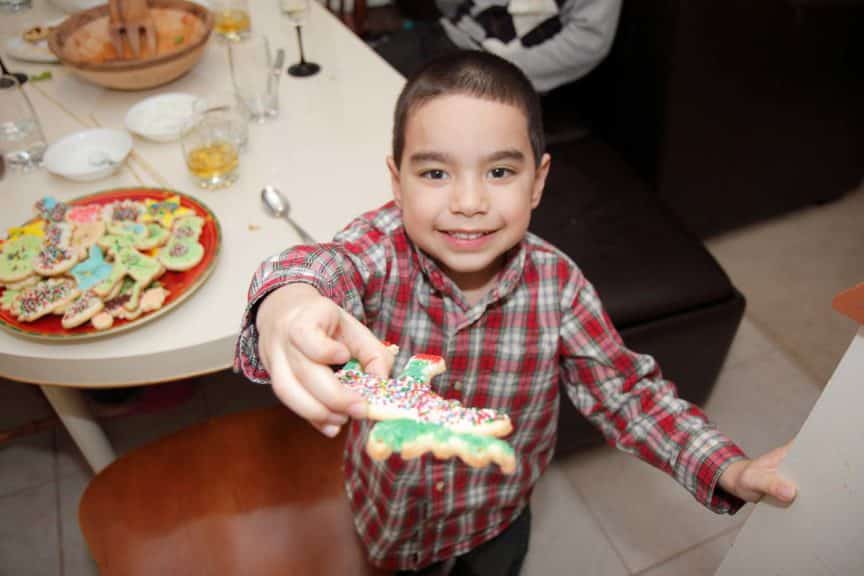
718,441,798,504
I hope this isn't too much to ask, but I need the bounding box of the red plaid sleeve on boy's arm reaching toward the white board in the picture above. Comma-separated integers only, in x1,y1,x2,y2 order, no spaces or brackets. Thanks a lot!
561,272,746,514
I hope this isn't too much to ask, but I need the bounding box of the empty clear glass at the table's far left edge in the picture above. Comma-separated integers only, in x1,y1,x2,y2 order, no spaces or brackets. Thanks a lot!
0,75,45,172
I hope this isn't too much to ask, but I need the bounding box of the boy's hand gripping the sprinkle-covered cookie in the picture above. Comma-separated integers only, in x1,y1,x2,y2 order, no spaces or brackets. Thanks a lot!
256,284,393,437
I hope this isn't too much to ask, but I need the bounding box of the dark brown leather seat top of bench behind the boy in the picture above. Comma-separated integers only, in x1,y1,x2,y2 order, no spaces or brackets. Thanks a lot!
531,137,735,330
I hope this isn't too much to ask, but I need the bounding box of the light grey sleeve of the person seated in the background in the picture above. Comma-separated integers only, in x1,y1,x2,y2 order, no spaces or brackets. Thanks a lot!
483,0,621,92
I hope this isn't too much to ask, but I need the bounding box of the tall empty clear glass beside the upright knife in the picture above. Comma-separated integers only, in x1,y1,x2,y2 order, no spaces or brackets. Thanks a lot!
228,36,280,124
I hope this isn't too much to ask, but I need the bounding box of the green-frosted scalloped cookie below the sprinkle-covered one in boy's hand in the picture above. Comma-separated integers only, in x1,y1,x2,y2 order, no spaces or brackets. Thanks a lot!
366,419,516,474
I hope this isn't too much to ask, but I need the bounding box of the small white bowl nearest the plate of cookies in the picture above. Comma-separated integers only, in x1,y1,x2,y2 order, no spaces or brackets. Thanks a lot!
44,128,132,182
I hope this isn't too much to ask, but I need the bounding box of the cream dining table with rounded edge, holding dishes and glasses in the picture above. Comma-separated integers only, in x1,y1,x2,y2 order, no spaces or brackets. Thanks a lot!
0,0,404,472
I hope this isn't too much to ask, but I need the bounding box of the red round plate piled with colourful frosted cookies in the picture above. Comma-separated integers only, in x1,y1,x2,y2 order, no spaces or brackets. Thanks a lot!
0,188,221,340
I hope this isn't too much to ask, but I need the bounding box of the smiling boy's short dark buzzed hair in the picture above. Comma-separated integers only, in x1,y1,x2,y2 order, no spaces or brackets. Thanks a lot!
393,50,546,166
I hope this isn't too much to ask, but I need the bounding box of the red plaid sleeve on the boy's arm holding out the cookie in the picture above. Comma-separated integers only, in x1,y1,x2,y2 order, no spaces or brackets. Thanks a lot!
234,214,390,384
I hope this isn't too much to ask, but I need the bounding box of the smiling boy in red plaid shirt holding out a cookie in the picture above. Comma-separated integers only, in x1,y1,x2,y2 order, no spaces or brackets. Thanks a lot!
237,52,795,576
